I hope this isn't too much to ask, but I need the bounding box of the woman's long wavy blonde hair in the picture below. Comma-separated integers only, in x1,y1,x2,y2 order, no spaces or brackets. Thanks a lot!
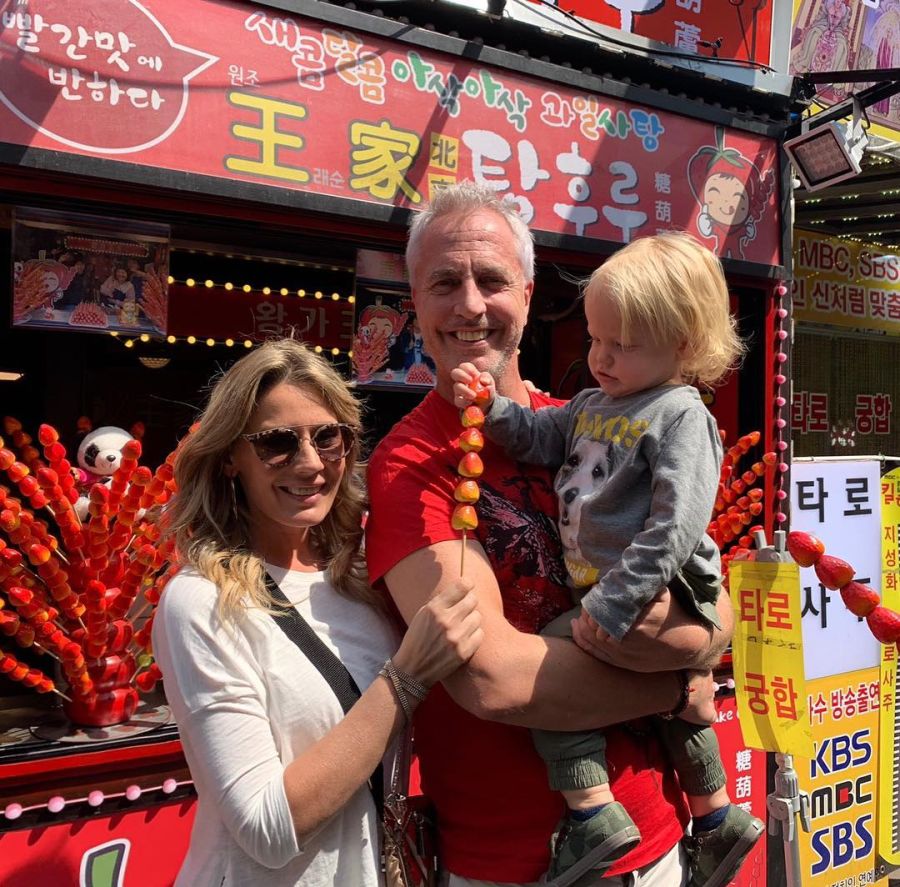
163,339,381,619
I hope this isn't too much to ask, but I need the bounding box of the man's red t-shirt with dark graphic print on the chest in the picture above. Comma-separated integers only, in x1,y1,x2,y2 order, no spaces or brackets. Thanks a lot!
366,391,687,883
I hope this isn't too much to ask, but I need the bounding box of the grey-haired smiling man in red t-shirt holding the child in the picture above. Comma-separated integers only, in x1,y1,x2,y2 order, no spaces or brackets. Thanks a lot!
366,183,732,887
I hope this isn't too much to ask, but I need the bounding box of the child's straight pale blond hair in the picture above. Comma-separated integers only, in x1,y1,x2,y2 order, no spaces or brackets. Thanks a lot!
584,231,745,386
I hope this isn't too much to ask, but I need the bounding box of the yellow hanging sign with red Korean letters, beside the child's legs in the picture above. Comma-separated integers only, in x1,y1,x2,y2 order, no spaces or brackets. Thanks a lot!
728,561,813,758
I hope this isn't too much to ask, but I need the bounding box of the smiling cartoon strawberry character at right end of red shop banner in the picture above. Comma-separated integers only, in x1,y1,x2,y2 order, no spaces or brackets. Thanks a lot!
688,126,775,259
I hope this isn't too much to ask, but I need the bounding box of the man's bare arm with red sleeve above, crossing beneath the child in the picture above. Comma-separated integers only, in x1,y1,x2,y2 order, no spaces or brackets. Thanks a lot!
385,540,696,730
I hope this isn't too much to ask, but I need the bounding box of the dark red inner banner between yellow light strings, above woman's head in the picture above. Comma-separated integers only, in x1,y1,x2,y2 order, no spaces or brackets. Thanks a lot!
168,284,353,351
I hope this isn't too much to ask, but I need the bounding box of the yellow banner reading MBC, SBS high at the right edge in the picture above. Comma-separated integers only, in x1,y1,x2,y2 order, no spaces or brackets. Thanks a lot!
791,230,900,336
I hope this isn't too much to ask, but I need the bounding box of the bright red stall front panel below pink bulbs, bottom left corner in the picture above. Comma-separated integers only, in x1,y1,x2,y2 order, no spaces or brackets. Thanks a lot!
0,798,196,887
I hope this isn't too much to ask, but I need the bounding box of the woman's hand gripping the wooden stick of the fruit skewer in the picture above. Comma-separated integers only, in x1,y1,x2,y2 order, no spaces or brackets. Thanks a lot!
393,577,484,687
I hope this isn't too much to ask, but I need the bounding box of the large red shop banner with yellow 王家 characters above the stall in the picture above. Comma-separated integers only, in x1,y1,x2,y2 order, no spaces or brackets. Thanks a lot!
0,0,781,265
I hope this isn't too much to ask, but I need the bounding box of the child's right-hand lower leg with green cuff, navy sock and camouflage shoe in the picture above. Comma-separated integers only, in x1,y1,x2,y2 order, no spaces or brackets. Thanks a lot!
660,718,765,887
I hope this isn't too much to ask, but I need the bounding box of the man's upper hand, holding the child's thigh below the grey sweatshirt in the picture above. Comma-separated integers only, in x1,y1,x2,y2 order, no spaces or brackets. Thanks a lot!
572,589,734,672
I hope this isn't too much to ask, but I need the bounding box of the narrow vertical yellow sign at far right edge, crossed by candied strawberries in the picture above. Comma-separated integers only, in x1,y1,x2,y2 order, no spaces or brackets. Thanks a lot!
878,468,900,865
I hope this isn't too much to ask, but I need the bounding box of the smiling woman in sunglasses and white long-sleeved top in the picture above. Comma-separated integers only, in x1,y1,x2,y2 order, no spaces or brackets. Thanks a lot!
153,340,482,887
